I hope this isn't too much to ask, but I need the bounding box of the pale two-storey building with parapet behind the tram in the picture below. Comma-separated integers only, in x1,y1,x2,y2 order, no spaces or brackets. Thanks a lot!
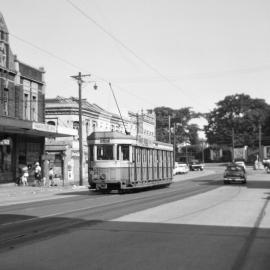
45,96,156,184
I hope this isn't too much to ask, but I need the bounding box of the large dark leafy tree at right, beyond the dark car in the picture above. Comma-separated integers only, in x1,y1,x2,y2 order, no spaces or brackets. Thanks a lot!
204,94,270,146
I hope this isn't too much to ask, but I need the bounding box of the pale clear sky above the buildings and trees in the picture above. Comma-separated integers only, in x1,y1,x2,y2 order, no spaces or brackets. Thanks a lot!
0,0,270,120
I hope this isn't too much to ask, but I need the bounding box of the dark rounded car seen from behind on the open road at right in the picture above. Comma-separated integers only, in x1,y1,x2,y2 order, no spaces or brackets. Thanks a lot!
223,164,247,184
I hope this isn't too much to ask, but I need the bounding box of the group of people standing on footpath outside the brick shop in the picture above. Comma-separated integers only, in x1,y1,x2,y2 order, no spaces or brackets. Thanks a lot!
16,162,56,186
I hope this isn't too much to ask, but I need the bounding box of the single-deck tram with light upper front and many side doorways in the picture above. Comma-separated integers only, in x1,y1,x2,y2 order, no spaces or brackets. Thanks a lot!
87,131,173,193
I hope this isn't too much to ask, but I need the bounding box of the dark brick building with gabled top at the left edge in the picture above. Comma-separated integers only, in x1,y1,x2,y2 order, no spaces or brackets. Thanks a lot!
0,13,75,183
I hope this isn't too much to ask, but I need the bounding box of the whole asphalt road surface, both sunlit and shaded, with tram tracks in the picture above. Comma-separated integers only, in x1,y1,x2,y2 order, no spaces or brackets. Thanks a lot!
0,169,270,270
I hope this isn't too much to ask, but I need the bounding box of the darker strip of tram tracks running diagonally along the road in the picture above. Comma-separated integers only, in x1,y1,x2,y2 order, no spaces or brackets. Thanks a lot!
0,173,219,251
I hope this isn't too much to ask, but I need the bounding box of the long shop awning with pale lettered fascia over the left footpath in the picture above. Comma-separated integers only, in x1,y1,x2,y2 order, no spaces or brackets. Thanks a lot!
0,117,78,137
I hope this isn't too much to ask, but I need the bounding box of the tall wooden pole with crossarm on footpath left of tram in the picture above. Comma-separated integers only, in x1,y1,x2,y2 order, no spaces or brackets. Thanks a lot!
71,72,91,186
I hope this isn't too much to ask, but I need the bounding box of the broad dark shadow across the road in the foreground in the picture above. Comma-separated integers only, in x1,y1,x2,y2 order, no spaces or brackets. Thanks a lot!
0,215,270,270
